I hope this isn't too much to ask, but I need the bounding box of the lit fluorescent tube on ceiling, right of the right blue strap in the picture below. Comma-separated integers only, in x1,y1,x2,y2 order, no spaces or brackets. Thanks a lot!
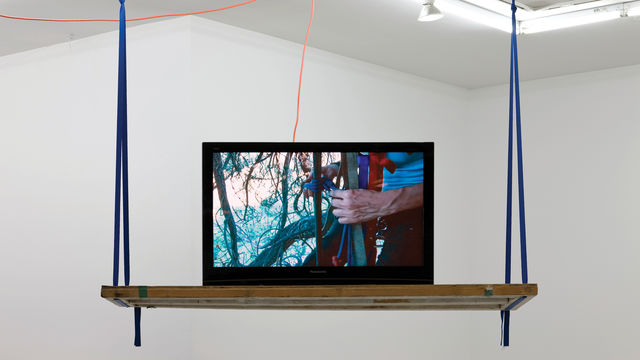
520,6,622,34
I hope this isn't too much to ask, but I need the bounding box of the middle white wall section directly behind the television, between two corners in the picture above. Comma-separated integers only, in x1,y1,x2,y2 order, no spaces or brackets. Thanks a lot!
185,18,476,359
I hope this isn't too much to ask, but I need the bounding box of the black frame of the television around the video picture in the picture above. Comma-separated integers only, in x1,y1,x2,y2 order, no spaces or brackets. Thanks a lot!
202,142,434,286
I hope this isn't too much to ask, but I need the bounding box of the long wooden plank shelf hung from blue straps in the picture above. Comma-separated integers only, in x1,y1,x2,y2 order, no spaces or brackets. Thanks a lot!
101,284,538,310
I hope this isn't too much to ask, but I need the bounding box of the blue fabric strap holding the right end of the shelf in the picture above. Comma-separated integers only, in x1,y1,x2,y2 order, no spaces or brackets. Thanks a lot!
500,0,529,346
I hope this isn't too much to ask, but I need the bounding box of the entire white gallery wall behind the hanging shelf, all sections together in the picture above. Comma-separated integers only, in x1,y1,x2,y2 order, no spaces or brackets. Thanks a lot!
0,14,640,359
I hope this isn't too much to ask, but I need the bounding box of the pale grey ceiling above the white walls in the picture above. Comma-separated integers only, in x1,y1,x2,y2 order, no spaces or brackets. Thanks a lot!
0,0,640,89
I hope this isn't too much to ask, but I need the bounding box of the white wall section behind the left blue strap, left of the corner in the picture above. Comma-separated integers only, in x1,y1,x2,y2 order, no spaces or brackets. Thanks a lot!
0,19,199,359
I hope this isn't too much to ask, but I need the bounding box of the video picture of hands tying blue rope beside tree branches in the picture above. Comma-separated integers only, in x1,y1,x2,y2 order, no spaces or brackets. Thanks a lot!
211,152,425,268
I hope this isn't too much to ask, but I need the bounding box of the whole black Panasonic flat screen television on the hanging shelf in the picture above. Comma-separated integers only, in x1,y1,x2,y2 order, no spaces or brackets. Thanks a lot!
202,143,434,285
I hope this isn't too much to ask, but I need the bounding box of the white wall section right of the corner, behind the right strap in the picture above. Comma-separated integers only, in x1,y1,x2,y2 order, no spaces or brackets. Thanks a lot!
466,66,640,359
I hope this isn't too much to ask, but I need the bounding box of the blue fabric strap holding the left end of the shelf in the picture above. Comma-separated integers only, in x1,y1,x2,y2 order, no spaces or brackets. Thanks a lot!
113,0,141,346
